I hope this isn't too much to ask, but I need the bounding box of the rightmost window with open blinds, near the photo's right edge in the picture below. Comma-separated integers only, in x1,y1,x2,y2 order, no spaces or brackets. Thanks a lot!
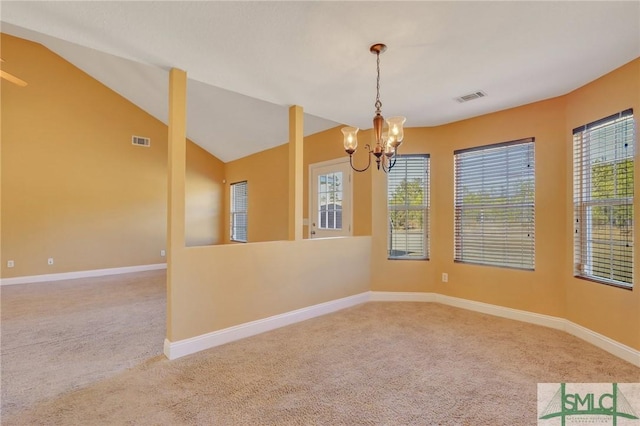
573,109,635,288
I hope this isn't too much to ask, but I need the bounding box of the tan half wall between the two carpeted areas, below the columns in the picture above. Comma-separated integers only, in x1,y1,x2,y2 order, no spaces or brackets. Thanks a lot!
167,237,371,342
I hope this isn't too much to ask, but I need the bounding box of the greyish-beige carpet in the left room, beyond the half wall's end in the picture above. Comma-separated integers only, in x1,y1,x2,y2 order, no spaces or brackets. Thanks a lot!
0,271,166,423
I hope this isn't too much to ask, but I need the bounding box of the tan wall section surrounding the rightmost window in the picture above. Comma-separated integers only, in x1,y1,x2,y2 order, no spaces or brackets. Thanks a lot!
558,59,640,349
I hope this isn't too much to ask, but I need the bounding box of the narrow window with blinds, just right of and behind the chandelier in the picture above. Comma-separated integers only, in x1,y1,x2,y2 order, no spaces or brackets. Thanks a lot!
387,155,429,259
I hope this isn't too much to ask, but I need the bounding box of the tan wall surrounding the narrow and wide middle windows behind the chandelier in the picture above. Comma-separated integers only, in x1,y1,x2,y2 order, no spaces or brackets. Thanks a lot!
372,99,565,316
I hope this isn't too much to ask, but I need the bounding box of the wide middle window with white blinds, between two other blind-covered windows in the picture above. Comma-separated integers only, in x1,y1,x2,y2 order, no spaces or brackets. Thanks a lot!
454,138,535,270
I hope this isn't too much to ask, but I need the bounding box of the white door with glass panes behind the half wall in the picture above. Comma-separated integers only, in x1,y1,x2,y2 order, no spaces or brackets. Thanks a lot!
309,161,352,238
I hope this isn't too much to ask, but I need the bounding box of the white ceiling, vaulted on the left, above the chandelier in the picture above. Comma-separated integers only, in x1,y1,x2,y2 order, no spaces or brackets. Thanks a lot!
0,0,640,161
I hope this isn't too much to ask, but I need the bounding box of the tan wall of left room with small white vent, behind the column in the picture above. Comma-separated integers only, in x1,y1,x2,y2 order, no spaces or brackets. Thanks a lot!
1,34,224,278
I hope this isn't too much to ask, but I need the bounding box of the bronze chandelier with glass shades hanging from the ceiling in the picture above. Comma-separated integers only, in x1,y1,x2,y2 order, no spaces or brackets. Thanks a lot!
342,43,406,173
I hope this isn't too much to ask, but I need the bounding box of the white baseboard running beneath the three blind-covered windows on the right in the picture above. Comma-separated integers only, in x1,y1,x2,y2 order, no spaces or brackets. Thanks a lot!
370,291,640,367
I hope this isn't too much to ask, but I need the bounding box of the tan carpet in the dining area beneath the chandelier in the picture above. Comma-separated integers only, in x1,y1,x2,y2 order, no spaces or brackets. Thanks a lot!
2,272,640,425
